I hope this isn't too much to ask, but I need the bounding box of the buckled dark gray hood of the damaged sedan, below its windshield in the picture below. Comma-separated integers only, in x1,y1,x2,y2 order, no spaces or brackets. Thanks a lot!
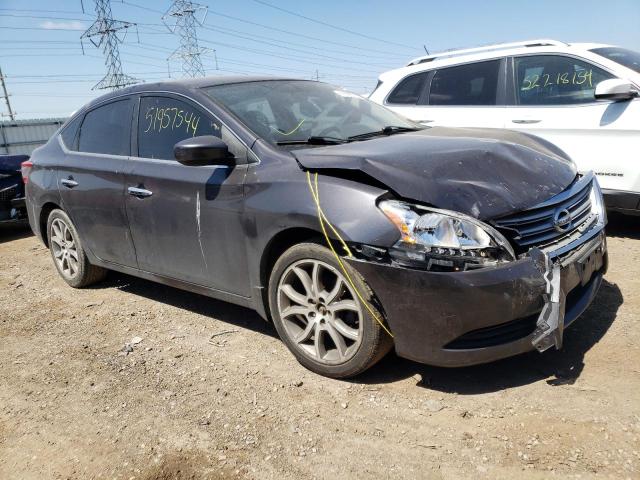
291,127,577,220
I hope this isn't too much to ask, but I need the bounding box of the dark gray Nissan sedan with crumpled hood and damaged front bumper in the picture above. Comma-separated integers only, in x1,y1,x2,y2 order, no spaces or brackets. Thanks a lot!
23,77,607,377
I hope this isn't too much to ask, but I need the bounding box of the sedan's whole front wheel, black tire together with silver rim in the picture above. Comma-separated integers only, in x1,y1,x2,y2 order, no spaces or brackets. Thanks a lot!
269,243,393,378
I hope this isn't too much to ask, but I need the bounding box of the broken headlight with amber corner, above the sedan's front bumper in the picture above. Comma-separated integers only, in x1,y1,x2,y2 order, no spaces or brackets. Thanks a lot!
378,200,515,271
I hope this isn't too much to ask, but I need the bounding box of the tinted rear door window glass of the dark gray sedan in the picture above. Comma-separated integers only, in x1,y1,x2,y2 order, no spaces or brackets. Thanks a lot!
78,99,131,155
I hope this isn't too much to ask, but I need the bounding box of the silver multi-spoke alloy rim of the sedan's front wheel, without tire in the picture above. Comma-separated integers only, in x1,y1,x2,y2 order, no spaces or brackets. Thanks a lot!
277,259,363,364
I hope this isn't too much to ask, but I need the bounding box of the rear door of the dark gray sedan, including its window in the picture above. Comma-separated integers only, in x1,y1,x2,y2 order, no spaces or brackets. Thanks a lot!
58,97,136,267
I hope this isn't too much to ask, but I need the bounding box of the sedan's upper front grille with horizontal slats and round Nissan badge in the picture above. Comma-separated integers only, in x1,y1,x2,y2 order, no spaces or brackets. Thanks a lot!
492,176,593,254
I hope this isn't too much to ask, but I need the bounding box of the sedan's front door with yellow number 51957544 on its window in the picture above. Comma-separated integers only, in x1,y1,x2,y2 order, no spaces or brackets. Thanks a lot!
126,94,249,296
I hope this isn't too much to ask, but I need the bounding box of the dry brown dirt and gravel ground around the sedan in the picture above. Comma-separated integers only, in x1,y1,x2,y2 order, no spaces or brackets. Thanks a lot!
0,217,640,479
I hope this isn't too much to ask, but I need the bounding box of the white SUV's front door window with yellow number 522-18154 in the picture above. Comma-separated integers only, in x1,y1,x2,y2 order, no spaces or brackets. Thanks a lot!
515,55,614,105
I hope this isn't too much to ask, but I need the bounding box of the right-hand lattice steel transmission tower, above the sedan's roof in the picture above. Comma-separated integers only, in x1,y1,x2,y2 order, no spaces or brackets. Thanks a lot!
162,0,211,77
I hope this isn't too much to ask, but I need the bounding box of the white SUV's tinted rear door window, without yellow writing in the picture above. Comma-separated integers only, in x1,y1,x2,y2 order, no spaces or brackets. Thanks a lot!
429,60,500,105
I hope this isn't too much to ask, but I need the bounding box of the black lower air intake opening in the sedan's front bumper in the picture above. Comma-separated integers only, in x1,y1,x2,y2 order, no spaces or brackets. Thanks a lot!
444,312,540,350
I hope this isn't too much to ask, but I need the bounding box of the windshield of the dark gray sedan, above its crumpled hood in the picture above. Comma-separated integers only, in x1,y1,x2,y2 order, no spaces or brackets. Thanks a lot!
203,80,422,145
